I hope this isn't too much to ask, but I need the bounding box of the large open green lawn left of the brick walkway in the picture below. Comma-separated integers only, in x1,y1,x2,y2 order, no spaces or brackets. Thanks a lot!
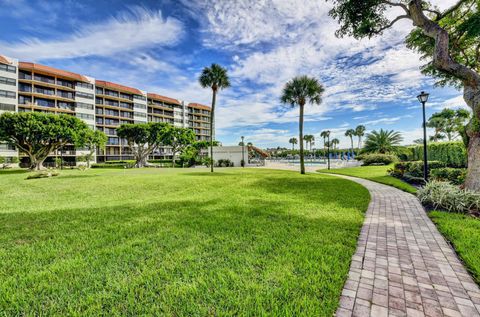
0,169,370,316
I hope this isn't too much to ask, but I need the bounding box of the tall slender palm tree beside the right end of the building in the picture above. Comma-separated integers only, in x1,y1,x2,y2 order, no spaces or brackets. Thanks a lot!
198,64,230,173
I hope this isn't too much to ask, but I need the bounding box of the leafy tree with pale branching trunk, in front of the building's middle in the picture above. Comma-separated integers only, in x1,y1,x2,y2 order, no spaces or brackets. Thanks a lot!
117,122,171,167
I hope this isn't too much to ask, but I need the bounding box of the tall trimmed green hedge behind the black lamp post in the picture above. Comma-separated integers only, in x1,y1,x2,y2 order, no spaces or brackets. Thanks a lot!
408,142,467,167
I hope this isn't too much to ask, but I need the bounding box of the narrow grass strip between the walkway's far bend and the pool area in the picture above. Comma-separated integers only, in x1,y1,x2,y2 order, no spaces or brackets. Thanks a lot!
318,165,417,194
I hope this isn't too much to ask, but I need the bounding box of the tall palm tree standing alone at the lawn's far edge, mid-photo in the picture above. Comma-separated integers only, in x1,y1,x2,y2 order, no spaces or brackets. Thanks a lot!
281,76,325,174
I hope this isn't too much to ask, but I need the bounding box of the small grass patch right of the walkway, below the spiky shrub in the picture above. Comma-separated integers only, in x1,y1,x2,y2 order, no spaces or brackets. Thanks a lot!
429,211,480,284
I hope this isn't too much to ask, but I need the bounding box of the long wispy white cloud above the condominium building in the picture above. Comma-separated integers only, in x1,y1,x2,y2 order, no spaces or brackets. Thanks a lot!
0,7,183,60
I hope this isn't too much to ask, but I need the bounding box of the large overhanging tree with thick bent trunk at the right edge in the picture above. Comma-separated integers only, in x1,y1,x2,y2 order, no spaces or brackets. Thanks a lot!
330,0,480,191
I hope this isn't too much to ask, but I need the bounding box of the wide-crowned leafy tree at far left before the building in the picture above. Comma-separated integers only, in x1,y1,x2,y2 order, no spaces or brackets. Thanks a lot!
0,112,89,170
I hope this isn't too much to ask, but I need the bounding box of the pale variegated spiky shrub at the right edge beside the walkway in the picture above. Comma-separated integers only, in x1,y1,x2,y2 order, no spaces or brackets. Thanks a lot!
417,181,480,213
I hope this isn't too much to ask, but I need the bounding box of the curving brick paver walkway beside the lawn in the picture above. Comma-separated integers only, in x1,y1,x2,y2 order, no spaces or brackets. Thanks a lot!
336,177,480,317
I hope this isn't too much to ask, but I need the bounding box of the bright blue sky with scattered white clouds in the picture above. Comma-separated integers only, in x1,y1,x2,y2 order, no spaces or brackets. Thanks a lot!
0,0,464,147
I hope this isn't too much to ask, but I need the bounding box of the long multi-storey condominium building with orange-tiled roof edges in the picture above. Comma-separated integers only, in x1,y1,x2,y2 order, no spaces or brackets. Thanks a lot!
0,55,211,165
